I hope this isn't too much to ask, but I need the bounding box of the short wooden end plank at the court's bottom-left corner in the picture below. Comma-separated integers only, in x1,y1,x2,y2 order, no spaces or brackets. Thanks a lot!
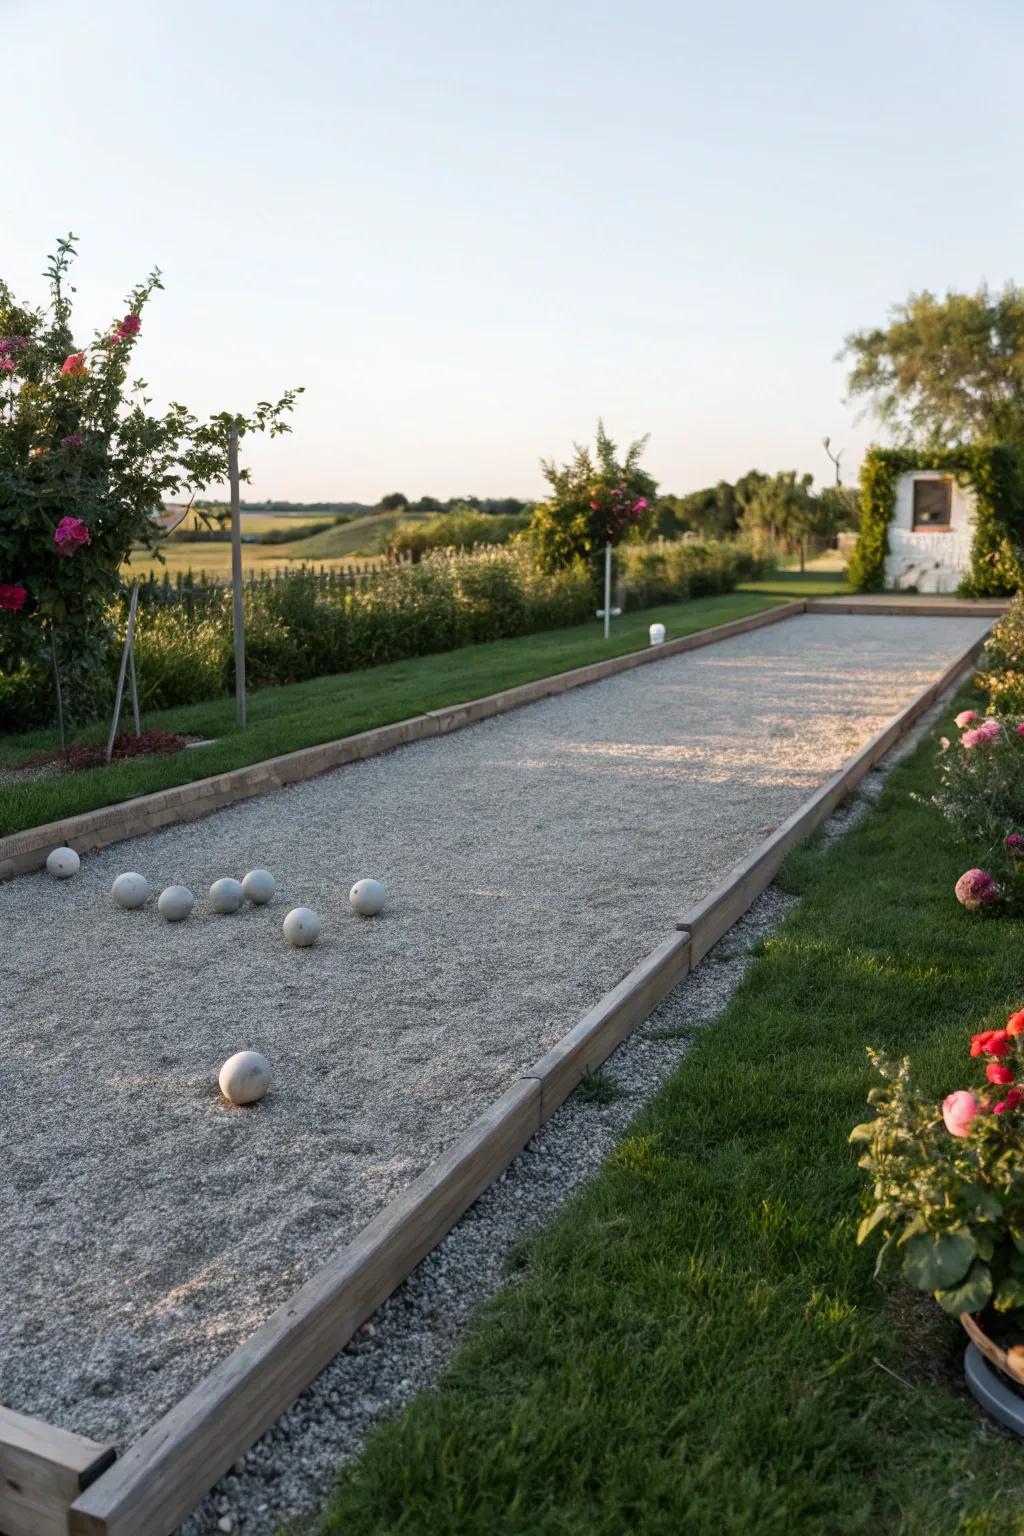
0,1405,114,1536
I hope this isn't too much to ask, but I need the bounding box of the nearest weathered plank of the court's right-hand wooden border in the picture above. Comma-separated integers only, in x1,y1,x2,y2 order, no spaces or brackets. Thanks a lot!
69,1080,540,1536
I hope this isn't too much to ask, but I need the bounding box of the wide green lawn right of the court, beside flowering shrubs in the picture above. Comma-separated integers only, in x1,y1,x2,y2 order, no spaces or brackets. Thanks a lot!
319,707,1024,1536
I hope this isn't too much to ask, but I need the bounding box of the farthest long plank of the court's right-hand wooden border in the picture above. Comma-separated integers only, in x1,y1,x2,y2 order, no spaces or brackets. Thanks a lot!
676,636,984,969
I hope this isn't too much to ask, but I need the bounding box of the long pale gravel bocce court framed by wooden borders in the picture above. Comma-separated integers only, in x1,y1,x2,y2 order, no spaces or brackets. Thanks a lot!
0,616,987,1444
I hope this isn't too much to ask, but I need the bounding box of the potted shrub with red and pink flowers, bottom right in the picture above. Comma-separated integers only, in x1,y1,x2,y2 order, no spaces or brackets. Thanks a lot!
851,1009,1024,1313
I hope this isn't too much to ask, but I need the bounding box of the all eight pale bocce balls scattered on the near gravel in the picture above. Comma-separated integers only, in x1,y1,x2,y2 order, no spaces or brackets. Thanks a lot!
46,848,385,1104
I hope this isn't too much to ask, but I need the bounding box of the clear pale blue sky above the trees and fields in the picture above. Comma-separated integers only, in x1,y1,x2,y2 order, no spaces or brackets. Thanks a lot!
0,0,1024,501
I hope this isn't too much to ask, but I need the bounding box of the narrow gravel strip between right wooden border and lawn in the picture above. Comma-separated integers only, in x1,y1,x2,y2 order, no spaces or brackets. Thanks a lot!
181,708,938,1536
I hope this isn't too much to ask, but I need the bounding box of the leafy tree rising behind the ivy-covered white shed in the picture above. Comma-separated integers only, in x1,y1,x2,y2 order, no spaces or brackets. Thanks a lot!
840,283,1024,447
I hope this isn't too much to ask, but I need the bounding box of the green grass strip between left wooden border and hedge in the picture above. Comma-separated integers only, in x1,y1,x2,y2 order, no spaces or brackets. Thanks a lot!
0,573,843,836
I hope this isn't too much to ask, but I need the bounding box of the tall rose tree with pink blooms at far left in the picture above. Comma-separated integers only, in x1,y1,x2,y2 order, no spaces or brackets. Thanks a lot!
0,235,301,715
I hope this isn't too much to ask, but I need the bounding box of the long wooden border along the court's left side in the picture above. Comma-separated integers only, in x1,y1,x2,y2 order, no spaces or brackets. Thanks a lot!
0,602,804,880
